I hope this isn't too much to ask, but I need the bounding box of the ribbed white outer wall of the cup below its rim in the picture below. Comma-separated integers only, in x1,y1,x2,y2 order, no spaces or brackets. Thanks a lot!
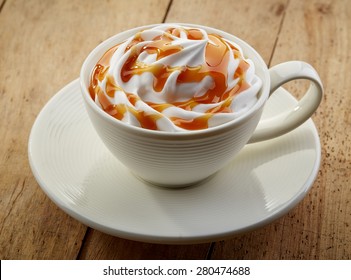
87,104,262,187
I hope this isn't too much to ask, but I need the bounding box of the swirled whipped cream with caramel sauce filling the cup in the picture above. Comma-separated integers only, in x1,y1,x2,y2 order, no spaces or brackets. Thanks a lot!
89,24,262,131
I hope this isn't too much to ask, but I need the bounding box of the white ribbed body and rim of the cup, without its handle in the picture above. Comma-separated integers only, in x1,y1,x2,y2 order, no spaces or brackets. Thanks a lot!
80,24,270,187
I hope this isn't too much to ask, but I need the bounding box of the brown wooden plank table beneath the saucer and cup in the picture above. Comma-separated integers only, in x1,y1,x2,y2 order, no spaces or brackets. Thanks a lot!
0,0,351,259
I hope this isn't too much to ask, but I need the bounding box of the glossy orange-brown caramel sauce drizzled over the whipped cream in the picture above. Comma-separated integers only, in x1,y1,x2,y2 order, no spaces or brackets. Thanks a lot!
89,28,249,130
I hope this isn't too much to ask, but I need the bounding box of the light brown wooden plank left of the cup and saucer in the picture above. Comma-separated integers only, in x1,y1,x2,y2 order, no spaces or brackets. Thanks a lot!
0,0,168,259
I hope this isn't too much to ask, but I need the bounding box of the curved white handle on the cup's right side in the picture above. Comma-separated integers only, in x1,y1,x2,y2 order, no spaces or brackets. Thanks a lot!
248,61,323,143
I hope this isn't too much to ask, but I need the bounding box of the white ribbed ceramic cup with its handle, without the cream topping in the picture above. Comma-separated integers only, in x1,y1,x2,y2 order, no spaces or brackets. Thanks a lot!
80,24,323,187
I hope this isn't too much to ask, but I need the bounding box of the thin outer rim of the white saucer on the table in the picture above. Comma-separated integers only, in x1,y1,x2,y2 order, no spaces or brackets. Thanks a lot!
28,79,321,244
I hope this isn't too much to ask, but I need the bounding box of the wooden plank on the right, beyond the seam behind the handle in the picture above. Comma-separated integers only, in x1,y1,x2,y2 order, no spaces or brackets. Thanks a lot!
212,0,351,259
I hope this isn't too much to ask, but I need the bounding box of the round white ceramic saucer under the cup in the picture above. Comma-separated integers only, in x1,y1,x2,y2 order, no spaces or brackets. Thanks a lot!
28,80,321,244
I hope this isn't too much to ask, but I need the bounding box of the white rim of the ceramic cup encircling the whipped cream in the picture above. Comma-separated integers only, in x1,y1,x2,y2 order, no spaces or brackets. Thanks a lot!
79,23,270,140
